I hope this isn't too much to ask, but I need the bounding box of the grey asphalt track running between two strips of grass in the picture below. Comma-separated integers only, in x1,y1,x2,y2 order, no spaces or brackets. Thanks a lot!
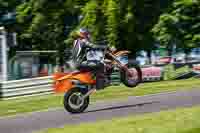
0,89,200,133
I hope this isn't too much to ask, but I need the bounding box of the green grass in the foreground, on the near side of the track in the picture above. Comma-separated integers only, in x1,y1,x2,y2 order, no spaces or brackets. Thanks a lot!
37,107,200,133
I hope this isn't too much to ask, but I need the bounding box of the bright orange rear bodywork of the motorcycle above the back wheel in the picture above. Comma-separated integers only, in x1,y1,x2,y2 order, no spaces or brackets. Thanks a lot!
53,72,95,93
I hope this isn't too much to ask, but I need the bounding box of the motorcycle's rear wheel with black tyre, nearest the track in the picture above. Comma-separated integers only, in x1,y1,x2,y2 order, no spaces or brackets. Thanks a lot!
64,88,90,113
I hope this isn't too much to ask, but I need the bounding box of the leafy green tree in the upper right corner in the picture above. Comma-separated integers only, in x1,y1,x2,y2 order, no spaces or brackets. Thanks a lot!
152,0,200,52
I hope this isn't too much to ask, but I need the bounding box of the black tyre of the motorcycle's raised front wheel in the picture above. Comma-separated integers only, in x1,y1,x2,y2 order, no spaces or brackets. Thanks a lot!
121,64,142,87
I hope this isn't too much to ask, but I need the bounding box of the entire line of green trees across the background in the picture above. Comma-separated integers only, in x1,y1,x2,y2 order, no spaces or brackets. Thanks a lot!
0,0,200,60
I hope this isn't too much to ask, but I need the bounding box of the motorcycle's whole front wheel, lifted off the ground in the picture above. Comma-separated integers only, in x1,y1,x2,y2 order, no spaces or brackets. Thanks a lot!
121,64,142,87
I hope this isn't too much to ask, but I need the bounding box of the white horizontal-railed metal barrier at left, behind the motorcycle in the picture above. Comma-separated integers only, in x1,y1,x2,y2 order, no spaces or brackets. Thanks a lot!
0,76,53,98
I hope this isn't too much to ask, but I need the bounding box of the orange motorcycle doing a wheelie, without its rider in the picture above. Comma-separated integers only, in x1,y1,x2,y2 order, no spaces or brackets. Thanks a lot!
54,45,142,113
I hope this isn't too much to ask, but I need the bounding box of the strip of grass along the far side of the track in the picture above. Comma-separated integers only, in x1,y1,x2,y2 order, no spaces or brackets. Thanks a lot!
0,79,200,116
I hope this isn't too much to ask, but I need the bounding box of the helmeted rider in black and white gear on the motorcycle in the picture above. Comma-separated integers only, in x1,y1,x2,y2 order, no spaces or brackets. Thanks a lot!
72,28,105,89
